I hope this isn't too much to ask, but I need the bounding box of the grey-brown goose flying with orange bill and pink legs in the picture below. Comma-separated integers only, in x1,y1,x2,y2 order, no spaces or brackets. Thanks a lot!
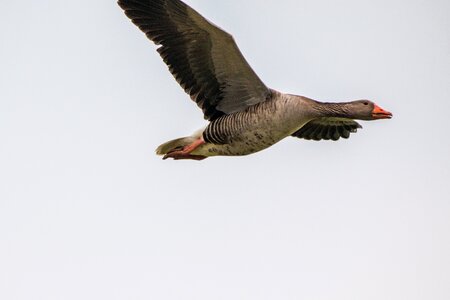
118,0,392,160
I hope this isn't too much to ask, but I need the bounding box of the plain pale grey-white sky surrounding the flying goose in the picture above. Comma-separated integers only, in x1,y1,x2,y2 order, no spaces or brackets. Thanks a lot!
0,0,450,300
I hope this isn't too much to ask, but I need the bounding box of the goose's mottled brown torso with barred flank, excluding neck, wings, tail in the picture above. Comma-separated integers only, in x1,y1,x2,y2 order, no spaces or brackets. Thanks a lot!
187,91,313,156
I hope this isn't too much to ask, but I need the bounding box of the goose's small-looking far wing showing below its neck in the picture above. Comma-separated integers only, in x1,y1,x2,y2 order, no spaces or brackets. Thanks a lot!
292,118,362,141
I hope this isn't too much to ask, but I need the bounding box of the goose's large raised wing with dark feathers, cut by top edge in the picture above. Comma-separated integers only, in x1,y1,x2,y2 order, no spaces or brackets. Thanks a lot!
118,0,271,120
